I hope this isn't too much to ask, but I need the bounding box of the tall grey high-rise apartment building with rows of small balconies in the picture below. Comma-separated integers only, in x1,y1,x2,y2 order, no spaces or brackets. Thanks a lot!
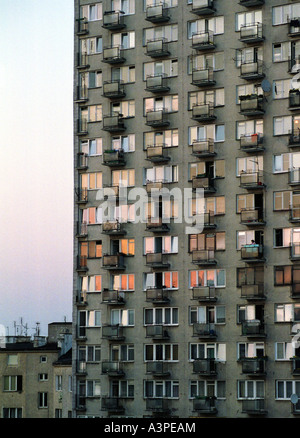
72,0,300,418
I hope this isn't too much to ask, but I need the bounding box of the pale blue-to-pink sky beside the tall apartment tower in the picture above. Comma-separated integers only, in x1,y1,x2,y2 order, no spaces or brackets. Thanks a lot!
0,0,74,335
